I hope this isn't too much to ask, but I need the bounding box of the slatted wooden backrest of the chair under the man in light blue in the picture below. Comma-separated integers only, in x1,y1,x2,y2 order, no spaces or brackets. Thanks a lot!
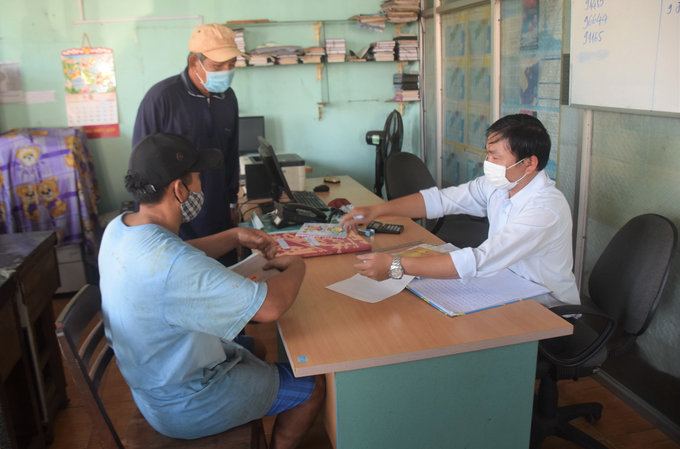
56,285,123,449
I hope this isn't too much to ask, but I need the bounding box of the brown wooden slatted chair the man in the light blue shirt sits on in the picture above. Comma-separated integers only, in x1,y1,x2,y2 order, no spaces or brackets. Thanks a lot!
56,285,267,449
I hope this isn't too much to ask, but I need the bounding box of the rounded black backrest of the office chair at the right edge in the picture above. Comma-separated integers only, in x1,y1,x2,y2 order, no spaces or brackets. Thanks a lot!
588,214,678,337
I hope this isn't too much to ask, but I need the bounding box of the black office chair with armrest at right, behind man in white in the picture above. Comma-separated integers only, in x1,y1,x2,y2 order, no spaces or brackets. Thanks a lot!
530,214,678,449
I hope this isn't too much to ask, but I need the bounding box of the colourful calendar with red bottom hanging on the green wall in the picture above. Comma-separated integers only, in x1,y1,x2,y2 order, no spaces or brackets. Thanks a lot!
61,47,120,139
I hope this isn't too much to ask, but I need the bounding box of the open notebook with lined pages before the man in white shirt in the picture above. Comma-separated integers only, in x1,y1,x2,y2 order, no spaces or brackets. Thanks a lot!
406,269,550,317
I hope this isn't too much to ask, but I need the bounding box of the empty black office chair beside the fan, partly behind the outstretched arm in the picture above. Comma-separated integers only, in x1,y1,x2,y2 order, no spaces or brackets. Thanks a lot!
385,152,489,248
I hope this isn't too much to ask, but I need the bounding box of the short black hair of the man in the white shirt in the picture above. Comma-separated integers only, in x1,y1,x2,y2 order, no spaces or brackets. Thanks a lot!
486,114,551,170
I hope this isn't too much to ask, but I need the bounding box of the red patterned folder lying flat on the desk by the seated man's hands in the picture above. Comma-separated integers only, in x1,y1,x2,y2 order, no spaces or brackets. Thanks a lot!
272,232,371,257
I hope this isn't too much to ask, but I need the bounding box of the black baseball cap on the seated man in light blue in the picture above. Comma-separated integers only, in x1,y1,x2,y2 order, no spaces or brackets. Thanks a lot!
128,133,224,191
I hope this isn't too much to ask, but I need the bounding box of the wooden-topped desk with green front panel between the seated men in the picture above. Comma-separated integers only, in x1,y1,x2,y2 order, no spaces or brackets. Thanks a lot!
278,177,572,449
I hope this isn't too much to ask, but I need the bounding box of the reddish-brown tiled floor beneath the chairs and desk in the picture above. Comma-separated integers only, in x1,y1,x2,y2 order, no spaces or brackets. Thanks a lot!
50,299,680,449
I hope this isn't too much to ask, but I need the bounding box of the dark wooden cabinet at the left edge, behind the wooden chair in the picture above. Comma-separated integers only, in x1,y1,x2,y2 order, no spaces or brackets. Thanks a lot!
0,231,68,449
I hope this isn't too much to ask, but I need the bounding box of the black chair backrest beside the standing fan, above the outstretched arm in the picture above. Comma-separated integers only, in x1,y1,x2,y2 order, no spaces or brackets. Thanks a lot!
385,152,437,200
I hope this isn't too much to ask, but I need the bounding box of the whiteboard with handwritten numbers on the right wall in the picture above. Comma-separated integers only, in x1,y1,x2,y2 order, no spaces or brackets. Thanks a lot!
569,0,680,115
